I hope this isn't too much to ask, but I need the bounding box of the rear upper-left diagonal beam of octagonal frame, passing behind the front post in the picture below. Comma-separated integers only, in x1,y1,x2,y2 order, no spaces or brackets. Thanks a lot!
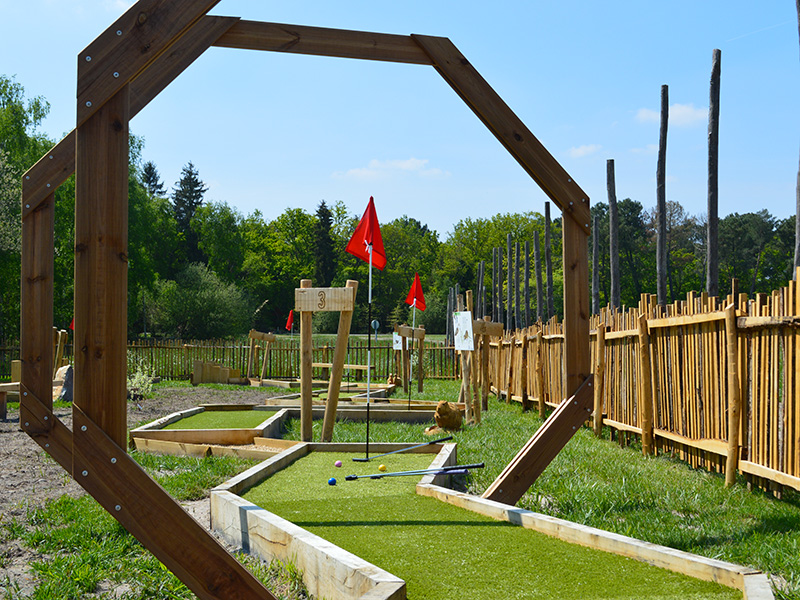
22,16,238,219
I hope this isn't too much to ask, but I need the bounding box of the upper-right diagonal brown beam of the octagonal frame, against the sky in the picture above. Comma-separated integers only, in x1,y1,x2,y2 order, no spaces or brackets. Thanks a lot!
411,35,591,233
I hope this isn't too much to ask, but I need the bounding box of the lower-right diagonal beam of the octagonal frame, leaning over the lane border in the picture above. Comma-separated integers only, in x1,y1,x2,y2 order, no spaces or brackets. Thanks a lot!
482,376,593,505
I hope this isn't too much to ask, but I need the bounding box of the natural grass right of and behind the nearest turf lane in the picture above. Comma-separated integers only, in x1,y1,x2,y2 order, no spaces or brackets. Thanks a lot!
284,381,800,600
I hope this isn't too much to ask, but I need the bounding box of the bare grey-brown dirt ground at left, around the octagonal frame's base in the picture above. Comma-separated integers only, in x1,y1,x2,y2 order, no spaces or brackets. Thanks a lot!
0,387,284,592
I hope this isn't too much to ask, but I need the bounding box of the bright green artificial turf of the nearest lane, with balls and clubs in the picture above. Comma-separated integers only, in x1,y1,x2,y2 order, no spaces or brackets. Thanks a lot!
244,452,742,600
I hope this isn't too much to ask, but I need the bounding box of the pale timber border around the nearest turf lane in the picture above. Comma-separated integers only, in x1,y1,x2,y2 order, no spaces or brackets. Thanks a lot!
211,442,774,600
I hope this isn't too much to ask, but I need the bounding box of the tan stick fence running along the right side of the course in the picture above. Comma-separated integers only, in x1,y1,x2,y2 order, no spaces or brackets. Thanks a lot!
490,276,800,490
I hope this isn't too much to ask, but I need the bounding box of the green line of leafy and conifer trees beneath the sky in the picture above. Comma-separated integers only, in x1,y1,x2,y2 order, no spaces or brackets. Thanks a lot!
0,76,794,339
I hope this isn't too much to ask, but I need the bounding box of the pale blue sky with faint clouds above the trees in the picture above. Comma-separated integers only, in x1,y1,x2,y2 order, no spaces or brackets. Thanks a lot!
0,0,800,238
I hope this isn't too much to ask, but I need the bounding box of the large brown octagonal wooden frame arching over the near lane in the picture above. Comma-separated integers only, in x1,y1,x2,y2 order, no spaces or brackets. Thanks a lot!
20,0,592,600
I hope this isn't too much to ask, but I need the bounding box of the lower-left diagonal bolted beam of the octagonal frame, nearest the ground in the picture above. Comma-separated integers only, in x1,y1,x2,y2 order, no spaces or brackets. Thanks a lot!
73,407,274,600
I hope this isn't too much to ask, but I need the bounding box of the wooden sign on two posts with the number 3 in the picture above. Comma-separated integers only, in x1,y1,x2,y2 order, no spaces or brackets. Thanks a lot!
294,279,358,442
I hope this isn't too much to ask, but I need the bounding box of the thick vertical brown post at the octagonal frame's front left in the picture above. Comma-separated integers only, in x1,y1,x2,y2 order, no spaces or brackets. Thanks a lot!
73,85,130,448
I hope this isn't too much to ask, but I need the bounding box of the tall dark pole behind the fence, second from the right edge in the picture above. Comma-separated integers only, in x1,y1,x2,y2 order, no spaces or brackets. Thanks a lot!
706,49,720,296
